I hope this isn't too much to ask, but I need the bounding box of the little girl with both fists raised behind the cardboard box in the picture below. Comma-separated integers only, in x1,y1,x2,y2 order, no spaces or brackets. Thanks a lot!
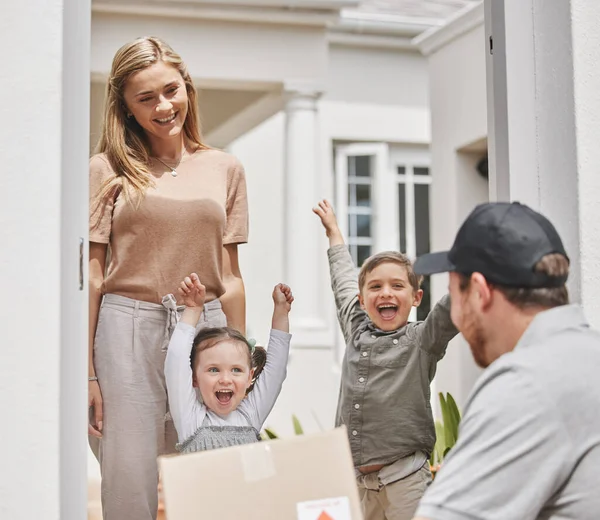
165,273,294,453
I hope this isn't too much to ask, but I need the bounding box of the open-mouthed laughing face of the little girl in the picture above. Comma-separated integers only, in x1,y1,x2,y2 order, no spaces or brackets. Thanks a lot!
194,339,253,416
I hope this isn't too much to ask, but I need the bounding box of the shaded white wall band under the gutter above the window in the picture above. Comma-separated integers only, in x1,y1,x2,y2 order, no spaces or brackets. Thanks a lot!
324,45,429,108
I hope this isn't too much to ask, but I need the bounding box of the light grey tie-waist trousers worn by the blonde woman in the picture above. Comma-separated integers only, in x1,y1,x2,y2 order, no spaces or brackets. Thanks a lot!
89,294,226,520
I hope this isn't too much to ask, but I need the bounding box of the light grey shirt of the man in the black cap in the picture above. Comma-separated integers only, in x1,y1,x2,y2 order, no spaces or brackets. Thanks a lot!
416,305,600,520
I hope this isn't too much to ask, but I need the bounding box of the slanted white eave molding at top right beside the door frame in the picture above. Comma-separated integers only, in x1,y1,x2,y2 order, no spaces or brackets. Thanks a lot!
412,2,484,56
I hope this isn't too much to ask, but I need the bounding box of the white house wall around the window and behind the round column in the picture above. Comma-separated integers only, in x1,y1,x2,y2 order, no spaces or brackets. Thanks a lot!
228,44,430,435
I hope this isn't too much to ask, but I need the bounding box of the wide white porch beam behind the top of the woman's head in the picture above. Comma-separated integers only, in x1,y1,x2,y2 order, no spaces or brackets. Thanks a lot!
91,13,327,86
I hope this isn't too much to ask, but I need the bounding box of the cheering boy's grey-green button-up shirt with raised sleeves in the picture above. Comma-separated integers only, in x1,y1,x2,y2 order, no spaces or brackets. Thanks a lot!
327,245,458,467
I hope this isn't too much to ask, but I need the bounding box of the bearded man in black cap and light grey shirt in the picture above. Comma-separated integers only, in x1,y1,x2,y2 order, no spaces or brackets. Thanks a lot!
415,203,600,520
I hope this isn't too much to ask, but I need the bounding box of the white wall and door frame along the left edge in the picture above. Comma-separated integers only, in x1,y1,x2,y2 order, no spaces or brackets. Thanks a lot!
0,0,90,520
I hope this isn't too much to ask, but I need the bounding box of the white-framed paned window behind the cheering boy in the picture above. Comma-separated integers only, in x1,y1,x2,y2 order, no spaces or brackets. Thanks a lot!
334,143,431,321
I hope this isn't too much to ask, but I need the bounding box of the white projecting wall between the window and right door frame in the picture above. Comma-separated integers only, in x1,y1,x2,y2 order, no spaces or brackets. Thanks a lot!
422,25,488,412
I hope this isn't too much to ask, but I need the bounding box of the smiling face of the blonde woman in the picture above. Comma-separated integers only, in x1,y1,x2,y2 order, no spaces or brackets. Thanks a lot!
124,61,188,143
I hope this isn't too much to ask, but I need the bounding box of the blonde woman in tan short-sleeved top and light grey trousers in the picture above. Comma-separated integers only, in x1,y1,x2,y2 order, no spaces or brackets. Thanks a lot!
89,38,248,520
